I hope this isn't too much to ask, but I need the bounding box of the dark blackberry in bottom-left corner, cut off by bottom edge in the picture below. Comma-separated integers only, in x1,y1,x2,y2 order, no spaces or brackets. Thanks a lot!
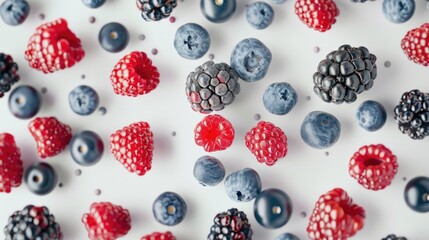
4,205,63,240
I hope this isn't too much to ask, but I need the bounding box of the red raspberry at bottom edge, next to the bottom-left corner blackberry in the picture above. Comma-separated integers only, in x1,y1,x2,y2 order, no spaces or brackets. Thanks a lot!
82,202,131,240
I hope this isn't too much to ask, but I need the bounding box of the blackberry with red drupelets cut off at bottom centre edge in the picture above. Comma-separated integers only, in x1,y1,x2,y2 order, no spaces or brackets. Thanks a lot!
207,208,253,240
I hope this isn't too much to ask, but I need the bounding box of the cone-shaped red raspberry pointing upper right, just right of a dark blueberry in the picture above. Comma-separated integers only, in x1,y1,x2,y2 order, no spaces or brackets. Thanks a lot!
110,122,153,176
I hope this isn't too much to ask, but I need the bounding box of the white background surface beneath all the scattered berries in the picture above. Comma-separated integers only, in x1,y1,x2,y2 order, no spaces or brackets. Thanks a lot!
0,0,429,240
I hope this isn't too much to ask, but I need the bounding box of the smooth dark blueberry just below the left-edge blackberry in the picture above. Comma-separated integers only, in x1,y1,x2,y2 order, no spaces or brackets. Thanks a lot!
8,85,42,119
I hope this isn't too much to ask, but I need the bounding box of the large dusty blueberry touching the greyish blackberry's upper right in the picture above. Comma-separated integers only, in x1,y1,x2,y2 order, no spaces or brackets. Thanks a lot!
231,38,272,82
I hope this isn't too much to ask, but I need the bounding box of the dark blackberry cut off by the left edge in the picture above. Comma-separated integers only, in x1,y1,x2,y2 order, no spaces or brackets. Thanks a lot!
0,53,19,98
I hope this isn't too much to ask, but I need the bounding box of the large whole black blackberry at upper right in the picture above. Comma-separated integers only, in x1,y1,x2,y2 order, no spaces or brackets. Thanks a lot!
313,45,377,104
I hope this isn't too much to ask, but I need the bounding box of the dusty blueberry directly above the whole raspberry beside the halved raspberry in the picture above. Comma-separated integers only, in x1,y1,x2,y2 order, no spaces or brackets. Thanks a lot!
262,82,298,115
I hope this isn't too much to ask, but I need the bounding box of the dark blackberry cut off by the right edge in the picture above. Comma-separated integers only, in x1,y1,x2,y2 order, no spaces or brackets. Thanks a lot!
394,89,429,139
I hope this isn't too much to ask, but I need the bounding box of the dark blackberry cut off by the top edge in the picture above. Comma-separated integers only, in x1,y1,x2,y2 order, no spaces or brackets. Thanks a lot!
137,0,177,22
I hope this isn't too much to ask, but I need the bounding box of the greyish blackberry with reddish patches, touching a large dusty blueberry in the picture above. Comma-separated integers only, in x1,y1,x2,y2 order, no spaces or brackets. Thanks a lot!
186,61,240,113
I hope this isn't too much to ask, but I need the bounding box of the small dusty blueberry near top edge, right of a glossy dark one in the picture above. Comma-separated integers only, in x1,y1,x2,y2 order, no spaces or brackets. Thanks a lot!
246,2,274,29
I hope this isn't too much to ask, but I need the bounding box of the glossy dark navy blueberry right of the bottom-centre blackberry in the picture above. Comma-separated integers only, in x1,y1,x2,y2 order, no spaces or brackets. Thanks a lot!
253,188,292,229
